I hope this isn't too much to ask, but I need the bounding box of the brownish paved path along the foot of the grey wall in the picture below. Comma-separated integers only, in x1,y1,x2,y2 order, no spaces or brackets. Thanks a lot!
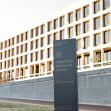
0,98,111,111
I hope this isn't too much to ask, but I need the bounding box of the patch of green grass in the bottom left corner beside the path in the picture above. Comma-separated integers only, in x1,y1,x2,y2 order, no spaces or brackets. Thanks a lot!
0,101,53,111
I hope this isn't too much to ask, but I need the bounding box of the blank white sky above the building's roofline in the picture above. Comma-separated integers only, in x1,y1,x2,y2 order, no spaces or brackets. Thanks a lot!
0,0,77,41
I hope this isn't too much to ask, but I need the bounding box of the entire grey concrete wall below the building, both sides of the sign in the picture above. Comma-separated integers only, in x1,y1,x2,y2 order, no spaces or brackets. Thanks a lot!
0,68,111,106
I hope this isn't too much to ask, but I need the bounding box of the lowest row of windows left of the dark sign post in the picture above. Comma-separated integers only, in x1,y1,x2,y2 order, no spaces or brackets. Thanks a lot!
0,61,52,81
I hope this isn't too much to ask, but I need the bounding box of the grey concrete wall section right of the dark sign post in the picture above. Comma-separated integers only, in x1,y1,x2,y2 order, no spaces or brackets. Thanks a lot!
78,68,111,106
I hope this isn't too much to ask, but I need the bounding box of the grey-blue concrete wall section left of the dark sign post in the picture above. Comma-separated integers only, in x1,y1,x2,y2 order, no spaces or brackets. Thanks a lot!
0,78,54,101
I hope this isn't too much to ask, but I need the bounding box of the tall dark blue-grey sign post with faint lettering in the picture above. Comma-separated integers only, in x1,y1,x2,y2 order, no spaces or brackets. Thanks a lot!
53,39,78,111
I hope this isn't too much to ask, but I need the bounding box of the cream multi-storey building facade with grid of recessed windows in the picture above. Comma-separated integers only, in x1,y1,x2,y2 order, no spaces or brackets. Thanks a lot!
0,0,111,82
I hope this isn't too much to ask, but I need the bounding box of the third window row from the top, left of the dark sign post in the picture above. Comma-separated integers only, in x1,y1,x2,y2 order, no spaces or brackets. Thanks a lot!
0,48,52,69
